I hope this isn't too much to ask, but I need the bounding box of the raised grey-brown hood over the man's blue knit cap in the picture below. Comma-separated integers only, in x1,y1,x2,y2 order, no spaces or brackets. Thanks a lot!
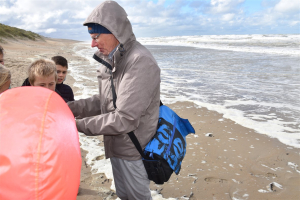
83,1,136,44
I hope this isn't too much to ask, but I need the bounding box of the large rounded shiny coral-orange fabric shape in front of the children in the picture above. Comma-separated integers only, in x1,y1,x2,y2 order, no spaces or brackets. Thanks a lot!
0,87,81,200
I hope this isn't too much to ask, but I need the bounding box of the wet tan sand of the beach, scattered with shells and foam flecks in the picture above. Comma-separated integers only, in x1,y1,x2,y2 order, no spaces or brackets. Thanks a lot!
1,38,300,200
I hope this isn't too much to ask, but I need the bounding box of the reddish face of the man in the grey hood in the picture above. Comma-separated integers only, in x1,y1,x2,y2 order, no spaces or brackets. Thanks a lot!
90,33,119,56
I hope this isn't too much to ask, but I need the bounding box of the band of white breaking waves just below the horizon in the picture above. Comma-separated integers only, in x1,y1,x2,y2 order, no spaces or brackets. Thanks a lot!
138,34,300,56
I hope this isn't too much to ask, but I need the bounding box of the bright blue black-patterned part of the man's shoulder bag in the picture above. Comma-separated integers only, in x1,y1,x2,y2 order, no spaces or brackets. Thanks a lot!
144,105,195,174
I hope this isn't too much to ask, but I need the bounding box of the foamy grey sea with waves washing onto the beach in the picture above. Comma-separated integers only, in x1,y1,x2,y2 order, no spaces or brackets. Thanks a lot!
69,34,300,199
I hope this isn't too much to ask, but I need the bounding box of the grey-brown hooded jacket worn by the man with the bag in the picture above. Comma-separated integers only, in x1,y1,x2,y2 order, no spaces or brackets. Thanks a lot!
68,1,160,160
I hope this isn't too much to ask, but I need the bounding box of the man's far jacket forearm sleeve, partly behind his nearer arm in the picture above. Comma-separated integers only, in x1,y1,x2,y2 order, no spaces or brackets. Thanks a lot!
67,95,101,119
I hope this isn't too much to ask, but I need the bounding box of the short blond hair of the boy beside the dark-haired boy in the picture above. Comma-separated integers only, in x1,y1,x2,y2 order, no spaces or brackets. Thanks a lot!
28,59,57,85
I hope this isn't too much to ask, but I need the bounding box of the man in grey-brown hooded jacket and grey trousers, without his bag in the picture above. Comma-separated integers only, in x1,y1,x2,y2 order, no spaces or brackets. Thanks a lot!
68,1,160,200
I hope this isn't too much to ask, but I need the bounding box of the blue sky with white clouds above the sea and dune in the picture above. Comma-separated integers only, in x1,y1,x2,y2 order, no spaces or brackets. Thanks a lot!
0,0,300,41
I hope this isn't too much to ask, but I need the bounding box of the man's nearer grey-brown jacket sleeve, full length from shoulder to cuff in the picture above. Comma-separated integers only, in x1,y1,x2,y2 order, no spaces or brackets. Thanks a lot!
76,56,160,135
